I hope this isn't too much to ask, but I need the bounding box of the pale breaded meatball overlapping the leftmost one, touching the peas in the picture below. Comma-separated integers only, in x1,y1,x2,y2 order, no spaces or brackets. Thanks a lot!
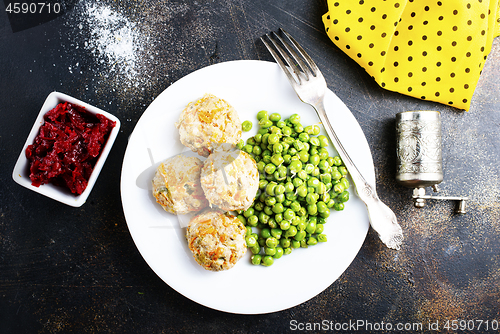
201,146,259,211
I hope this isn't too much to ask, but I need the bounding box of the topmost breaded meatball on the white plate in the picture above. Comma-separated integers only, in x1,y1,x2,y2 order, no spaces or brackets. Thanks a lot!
175,94,241,157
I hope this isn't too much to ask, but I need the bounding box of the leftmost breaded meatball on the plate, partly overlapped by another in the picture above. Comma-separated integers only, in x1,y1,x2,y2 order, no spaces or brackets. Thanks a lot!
153,155,208,214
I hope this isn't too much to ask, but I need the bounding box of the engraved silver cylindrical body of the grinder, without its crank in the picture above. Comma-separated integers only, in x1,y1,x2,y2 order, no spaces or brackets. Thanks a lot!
396,110,443,188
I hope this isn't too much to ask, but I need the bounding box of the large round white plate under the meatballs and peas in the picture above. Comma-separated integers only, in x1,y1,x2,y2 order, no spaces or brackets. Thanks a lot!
121,60,375,314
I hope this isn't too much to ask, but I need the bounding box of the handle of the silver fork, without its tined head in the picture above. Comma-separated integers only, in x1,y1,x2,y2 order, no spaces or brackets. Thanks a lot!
313,99,403,249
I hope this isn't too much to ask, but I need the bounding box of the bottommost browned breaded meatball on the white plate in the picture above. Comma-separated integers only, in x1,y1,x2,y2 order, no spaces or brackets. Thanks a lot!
186,209,247,271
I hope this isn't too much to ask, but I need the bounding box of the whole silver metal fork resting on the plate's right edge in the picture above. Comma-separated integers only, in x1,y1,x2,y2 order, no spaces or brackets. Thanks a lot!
260,29,403,249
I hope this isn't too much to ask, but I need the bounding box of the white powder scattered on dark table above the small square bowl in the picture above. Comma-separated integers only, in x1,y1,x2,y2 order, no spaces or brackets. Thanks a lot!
67,1,155,93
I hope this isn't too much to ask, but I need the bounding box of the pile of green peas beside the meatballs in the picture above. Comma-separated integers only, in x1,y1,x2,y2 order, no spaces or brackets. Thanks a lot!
238,110,349,266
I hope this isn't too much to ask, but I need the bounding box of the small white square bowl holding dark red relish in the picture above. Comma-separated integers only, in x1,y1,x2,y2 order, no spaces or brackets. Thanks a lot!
12,92,120,207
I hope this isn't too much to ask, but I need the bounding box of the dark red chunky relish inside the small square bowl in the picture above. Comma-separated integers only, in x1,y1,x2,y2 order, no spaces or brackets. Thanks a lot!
26,102,116,195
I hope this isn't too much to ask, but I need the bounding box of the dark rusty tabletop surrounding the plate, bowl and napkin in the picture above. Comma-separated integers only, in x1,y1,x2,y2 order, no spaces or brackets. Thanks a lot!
0,0,500,333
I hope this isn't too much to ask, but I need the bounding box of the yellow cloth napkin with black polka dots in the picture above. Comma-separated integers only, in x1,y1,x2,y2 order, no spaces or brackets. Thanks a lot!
323,0,500,110
